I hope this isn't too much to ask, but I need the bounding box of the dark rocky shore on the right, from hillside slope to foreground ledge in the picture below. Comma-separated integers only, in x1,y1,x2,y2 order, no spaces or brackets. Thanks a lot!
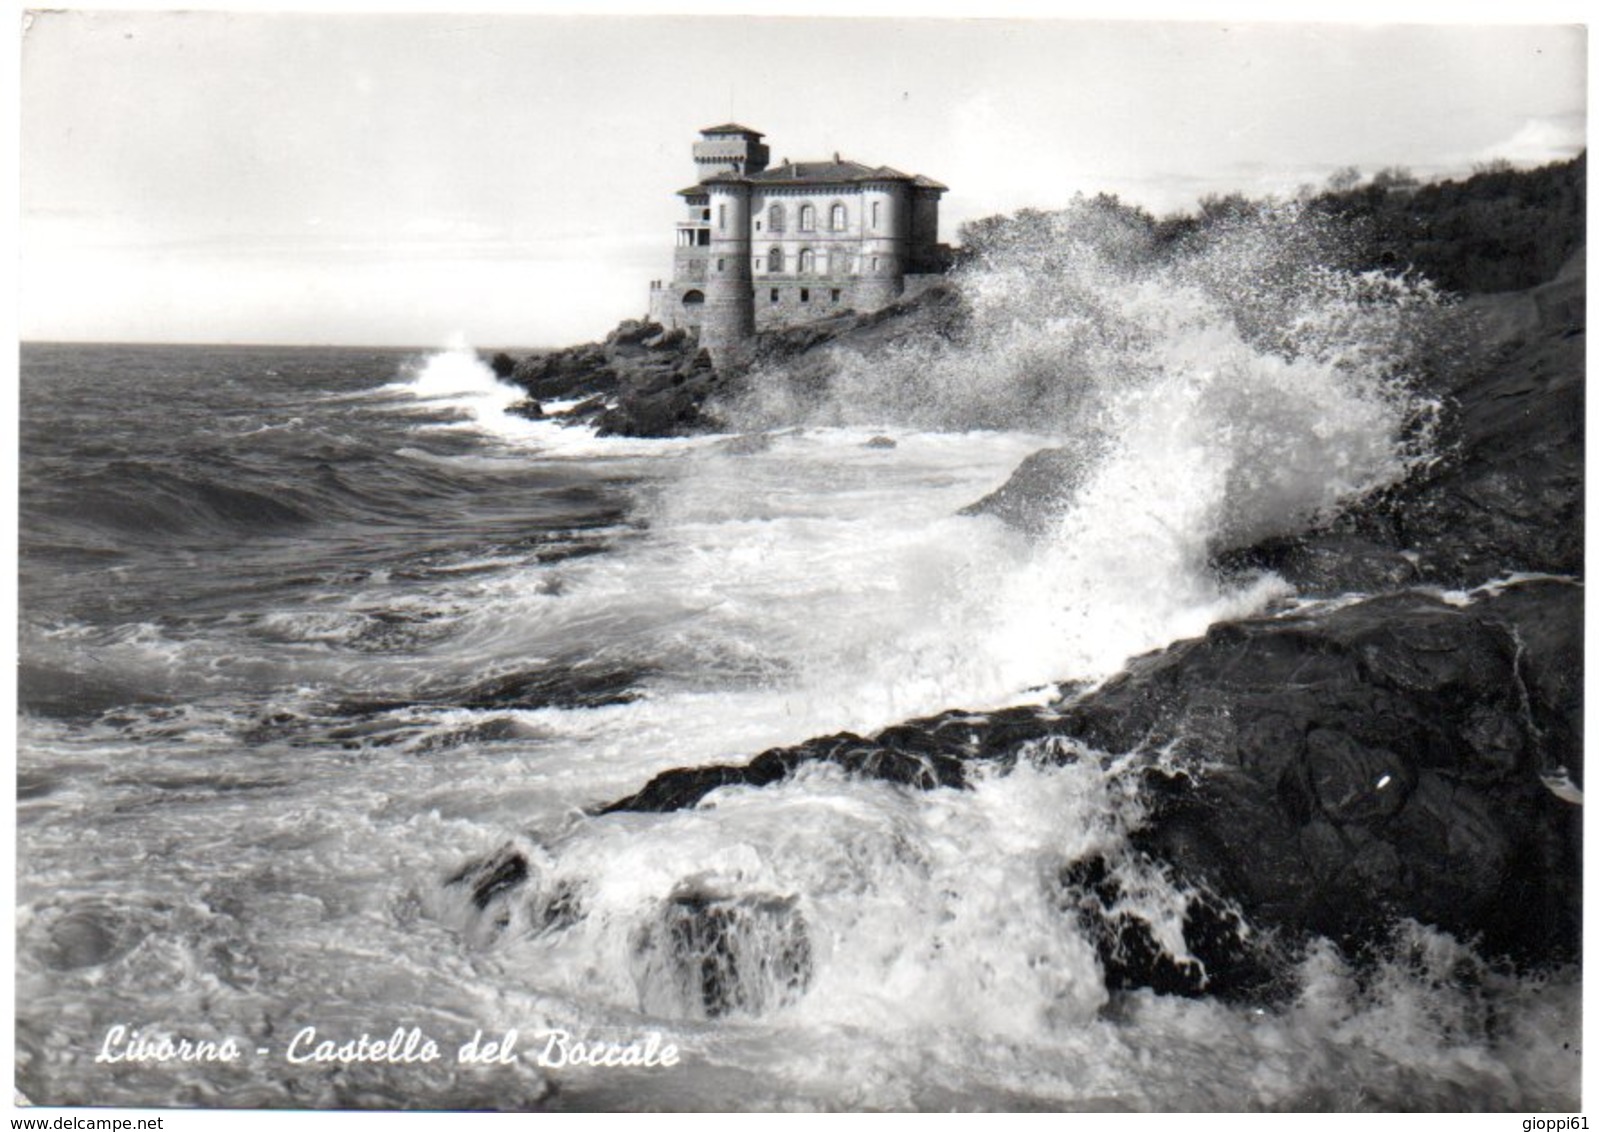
572,244,1585,996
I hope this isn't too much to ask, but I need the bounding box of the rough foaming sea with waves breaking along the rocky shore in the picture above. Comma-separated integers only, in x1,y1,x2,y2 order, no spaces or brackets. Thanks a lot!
14,219,1580,1111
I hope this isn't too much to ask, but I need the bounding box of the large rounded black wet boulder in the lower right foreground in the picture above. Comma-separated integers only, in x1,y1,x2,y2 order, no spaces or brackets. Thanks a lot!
1062,584,1581,958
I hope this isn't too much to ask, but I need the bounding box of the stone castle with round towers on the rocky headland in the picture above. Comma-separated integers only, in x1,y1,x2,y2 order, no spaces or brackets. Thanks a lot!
649,123,948,357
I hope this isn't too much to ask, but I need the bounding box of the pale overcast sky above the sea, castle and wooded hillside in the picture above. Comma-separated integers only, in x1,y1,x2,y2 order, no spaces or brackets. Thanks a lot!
19,11,1586,347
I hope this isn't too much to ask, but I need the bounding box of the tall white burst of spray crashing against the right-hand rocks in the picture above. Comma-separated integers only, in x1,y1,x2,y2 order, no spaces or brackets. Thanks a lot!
706,201,1450,692
